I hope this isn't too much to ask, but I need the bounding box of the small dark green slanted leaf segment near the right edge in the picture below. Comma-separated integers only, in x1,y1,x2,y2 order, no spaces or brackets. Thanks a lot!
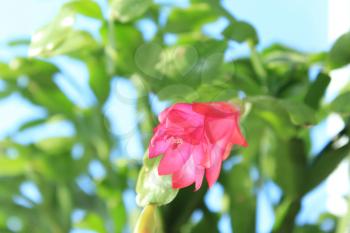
304,73,331,109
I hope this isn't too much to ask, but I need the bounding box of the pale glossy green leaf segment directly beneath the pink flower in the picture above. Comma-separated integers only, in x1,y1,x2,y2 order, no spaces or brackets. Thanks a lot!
136,152,179,206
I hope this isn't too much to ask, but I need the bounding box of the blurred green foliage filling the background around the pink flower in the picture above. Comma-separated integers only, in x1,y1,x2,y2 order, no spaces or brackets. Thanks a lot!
0,0,350,233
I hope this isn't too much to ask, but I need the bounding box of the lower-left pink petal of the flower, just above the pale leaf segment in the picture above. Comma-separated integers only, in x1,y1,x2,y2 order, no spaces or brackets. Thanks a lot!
158,143,191,175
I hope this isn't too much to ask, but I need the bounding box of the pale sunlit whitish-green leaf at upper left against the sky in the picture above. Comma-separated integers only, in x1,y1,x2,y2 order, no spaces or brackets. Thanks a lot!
29,10,97,57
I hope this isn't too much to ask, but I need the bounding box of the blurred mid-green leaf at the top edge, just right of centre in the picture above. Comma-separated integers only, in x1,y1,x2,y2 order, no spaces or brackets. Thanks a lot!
164,3,218,33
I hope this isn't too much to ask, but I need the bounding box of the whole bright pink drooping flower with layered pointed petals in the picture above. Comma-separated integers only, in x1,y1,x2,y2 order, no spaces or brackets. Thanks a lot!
149,102,247,190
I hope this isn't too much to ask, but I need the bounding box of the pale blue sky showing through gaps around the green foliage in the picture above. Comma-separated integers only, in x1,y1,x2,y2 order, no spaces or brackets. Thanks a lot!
0,0,350,233
